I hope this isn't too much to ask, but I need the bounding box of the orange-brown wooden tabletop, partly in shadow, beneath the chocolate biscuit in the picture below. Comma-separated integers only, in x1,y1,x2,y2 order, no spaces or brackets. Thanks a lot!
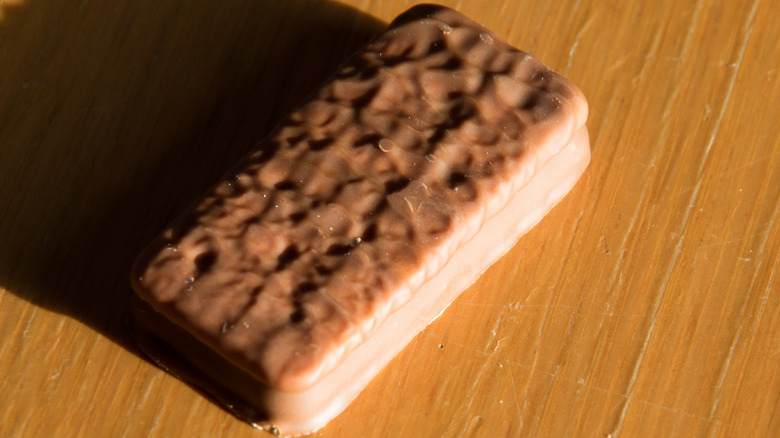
0,0,780,438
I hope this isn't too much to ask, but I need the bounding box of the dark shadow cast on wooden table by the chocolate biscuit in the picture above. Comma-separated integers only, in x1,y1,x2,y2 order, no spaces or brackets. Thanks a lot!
0,0,384,352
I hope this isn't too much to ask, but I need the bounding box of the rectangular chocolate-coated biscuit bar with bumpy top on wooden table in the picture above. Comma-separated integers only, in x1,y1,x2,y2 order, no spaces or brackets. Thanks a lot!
132,5,590,435
